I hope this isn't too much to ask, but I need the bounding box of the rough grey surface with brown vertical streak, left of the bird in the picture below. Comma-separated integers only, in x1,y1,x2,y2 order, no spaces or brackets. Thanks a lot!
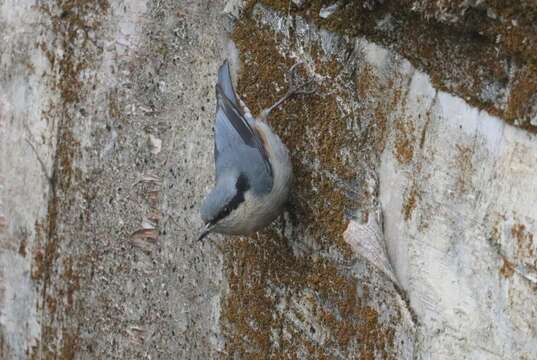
0,1,228,359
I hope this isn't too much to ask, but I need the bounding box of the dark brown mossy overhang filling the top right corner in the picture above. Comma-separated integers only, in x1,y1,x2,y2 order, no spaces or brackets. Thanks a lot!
255,0,537,132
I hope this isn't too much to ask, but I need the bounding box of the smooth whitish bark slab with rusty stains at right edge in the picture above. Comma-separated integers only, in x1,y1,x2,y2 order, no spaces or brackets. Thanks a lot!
379,67,537,359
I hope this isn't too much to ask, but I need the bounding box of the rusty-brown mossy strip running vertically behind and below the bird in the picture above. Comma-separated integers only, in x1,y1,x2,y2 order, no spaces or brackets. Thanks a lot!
222,8,406,359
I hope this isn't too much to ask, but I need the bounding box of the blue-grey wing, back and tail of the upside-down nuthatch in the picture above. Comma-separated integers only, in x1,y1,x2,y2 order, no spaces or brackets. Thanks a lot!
214,62,272,192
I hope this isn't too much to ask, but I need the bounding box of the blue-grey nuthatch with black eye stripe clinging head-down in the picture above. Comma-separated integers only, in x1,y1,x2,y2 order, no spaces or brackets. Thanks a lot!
198,61,312,240
